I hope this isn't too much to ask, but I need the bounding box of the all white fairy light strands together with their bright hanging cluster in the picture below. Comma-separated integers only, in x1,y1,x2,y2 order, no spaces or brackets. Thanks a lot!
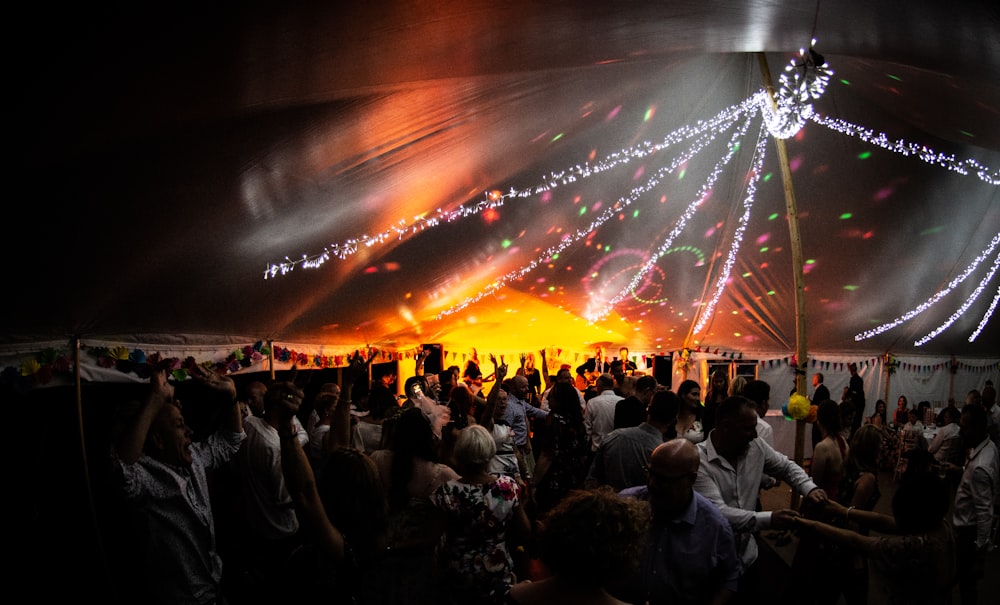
264,40,1000,346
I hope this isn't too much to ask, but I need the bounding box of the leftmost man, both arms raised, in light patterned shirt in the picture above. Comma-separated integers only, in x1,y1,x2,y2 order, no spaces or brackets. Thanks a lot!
112,367,246,605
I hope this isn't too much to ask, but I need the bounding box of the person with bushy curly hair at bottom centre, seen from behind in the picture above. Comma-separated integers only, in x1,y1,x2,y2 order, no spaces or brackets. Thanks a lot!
507,487,649,605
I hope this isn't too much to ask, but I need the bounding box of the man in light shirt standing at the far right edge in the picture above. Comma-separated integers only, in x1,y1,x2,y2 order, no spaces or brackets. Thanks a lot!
952,404,1000,605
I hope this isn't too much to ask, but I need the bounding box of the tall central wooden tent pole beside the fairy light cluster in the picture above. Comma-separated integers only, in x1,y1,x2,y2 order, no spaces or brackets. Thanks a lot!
757,52,809,508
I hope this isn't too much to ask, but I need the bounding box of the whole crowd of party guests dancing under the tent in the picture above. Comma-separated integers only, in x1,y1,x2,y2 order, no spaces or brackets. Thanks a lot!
110,350,1000,605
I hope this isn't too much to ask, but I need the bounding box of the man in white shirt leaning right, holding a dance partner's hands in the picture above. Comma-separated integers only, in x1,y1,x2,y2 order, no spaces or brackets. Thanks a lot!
694,397,827,603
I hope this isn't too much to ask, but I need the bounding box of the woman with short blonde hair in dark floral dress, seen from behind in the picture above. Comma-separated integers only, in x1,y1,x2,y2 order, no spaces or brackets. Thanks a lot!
431,425,531,604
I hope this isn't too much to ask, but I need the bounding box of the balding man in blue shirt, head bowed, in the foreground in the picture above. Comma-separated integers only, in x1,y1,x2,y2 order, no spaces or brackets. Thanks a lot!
615,438,740,605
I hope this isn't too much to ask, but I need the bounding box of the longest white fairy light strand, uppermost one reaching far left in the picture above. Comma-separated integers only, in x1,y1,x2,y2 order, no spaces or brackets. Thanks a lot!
264,97,755,279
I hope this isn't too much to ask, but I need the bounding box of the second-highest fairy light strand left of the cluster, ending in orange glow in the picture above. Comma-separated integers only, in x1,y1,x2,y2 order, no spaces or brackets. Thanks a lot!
438,109,743,319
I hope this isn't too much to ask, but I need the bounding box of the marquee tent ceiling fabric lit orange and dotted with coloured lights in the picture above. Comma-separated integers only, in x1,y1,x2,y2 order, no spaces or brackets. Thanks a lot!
13,0,1000,356
